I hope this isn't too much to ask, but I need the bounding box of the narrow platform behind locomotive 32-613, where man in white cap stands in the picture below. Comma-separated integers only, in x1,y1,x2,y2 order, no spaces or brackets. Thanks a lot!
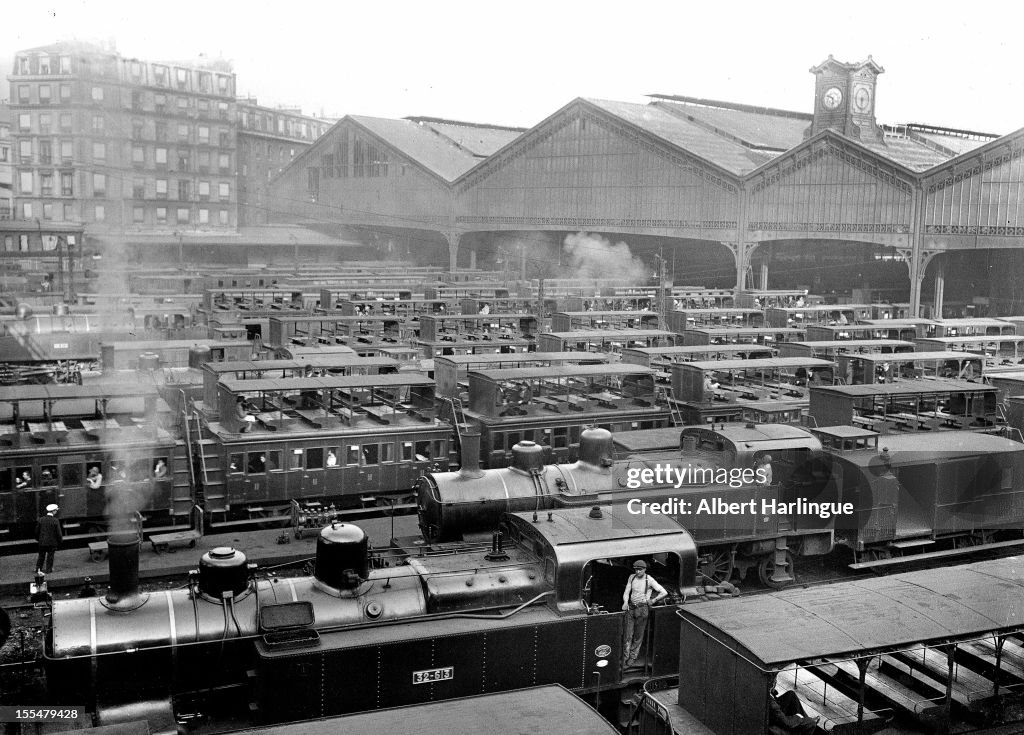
0,515,419,597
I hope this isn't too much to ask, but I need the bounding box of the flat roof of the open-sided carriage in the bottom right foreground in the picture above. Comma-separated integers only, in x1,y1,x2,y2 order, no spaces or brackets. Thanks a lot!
682,557,1024,667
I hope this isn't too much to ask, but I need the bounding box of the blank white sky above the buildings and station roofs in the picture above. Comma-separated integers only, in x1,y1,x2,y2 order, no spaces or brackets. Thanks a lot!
0,0,1024,134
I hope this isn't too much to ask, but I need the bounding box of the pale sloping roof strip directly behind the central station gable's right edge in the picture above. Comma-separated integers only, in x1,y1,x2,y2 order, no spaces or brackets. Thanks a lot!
587,99,753,175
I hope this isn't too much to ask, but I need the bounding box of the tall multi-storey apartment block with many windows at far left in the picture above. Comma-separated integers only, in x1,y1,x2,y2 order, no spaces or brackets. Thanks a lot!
9,42,238,234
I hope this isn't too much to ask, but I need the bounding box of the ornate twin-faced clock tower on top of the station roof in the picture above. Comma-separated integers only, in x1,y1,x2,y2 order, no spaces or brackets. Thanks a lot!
805,56,886,142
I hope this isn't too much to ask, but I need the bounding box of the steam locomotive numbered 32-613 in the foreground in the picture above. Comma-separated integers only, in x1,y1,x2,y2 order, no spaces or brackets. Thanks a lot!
44,506,697,732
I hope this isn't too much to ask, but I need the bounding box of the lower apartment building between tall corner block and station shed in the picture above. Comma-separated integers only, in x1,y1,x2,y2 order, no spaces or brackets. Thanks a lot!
238,98,332,225
